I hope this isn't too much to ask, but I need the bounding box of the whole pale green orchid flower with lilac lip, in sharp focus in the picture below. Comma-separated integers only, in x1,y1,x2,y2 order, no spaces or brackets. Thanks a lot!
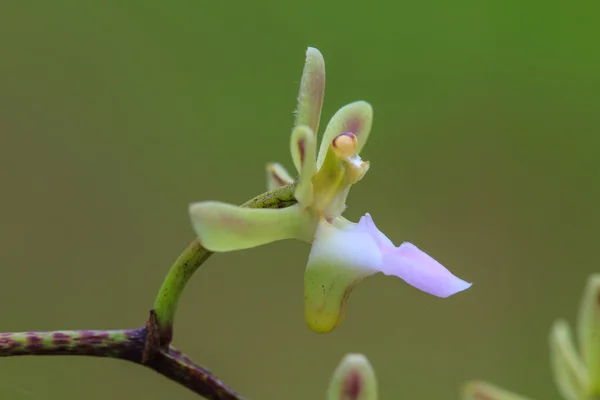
190,48,471,333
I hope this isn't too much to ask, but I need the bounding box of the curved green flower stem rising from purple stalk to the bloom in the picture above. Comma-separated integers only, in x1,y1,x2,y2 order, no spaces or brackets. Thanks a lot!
154,184,296,346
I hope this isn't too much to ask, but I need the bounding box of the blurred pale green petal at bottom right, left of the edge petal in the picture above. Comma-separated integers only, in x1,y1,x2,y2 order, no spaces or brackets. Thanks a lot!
550,320,589,400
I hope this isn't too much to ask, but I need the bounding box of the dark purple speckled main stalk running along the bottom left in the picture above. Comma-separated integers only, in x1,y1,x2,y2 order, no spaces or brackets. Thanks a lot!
0,327,243,400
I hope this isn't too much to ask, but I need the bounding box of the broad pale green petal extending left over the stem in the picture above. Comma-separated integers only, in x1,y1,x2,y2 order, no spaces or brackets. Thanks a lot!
190,201,312,252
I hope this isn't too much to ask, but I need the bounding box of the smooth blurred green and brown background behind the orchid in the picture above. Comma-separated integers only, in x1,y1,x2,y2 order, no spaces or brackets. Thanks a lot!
0,0,600,400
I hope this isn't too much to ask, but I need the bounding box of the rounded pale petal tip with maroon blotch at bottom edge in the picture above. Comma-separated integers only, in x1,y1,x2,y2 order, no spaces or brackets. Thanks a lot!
327,354,377,400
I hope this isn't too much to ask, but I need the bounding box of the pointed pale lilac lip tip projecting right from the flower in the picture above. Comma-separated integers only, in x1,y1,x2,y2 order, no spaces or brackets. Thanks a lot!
381,242,471,297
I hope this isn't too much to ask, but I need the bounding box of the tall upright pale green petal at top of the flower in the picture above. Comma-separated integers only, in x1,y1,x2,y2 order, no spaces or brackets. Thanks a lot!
294,47,325,135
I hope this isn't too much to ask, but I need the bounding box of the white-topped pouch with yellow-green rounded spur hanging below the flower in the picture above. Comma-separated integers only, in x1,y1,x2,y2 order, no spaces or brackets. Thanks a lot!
304,220,381,333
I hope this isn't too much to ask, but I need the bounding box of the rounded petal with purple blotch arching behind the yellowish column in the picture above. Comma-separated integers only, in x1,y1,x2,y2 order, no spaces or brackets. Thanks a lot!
317,101,373,168
